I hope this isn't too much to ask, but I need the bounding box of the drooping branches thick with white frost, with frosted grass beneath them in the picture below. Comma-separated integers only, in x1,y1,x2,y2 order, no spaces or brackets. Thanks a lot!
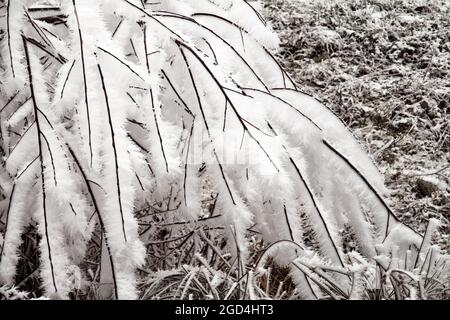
0,0,449,299
